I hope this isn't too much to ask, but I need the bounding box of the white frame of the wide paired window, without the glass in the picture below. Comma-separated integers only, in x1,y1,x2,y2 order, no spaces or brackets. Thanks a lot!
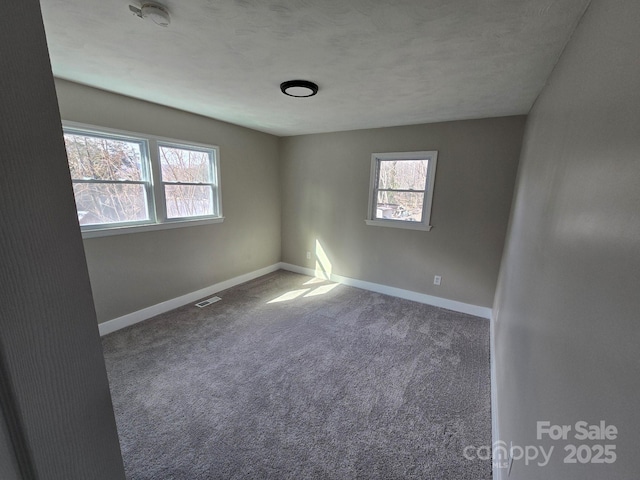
62,120,224,238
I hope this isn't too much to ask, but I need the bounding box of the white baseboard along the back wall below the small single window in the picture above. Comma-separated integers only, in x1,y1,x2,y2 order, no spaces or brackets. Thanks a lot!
280,263,491,319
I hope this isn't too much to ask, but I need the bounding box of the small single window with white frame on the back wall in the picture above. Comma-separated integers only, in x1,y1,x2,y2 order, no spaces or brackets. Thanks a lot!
366,151,438,230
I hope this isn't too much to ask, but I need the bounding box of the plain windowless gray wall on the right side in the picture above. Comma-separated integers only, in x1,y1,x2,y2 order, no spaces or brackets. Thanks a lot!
494,0,640,480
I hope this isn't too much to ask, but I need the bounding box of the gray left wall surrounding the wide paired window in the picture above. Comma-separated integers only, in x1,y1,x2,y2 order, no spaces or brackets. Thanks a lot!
56,79,280,322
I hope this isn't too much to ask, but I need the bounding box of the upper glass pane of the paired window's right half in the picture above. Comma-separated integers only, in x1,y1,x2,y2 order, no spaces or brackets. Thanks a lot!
160,145,211,183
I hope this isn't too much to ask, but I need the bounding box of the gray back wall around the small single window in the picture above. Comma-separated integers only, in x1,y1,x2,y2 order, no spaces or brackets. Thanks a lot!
280,116,525,307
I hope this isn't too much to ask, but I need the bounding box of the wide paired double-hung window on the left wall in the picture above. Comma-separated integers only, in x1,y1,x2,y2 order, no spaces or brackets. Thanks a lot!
64,122,223,237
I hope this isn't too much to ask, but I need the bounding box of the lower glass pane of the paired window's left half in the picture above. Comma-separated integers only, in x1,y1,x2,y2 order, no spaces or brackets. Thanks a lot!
73,183,149,225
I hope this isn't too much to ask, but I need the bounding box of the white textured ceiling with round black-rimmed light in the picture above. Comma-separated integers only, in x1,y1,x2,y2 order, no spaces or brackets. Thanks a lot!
41,0,589,135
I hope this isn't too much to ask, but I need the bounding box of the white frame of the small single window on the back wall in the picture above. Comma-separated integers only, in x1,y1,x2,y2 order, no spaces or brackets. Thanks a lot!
365,150,438,231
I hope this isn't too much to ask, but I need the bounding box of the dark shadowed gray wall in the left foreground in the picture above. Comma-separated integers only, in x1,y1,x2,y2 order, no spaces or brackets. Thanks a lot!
0,0,124,480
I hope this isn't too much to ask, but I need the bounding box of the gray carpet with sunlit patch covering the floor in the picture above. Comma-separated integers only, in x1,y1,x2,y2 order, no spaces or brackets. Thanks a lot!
103,271,491,480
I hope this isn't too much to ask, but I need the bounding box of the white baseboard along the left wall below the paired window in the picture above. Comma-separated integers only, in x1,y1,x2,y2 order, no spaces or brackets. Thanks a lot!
98,263,280,336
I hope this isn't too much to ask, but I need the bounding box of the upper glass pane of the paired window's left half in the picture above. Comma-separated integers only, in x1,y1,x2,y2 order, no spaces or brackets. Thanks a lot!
64,133,144,181
